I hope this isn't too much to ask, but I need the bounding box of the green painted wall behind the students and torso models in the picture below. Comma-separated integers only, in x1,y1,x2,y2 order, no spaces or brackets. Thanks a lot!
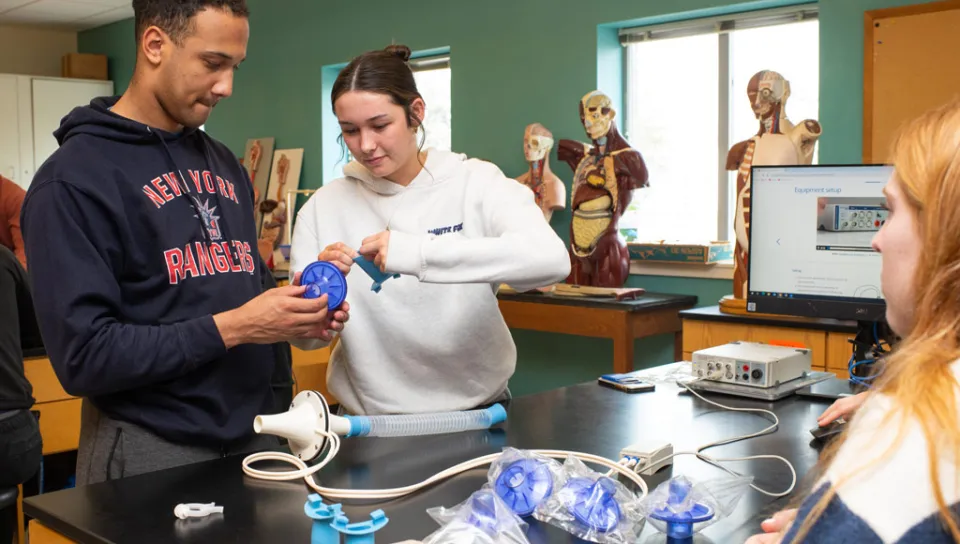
79,0,936,393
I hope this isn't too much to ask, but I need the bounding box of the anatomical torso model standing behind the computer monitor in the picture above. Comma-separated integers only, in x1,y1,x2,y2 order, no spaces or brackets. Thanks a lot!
721,70,821,307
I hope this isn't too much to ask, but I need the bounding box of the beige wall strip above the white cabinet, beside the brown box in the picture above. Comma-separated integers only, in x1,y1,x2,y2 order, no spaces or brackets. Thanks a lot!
0,25,77,77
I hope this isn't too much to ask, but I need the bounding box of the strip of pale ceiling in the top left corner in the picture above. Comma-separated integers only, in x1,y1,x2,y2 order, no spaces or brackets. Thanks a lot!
0,0,133,30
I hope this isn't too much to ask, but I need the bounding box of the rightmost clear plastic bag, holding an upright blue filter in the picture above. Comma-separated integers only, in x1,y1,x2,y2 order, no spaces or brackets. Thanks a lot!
641,476,753,543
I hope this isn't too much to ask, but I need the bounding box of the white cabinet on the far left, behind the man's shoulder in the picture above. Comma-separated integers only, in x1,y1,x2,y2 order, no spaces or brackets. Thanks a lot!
0,74,114,189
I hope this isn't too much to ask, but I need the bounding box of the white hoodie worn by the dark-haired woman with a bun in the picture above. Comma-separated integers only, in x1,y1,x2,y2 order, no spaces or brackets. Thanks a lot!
290,149,570,414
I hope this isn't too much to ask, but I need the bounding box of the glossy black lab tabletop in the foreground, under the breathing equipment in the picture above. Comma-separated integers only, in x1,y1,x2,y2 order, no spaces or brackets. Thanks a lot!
24,383,828,544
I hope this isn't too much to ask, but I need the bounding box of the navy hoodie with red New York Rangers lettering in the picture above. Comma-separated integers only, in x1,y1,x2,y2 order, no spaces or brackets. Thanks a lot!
22,97,274,447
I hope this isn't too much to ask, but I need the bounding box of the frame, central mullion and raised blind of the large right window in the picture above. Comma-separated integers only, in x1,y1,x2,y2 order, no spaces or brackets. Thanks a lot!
618,3,819,240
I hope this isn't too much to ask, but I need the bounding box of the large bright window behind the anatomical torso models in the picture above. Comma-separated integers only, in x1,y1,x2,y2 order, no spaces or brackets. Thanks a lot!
620,6,819,241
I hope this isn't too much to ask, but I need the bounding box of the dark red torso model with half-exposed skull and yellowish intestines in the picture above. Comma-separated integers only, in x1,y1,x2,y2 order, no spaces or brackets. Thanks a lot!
557,91,648,287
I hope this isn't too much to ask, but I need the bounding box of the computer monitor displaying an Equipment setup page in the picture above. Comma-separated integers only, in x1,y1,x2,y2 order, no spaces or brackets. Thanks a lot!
747,165,893,321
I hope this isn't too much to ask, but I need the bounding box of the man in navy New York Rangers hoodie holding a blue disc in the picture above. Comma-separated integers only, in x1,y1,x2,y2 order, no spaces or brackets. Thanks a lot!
22,0,349,484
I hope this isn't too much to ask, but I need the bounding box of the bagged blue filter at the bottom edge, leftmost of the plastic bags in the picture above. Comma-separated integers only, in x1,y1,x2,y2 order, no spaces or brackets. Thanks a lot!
423,486,529,544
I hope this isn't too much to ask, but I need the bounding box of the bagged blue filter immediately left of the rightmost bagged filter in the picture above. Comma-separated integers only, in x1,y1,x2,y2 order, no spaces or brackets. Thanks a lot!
533,457,644,544
